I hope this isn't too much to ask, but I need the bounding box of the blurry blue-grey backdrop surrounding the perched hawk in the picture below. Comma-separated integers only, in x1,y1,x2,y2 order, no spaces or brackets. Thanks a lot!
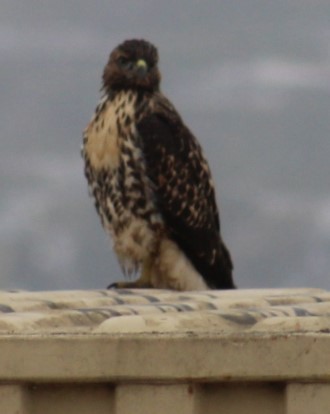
0,0,330,290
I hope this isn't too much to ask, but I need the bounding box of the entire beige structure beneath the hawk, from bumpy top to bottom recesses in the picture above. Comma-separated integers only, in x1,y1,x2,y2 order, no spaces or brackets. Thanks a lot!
0,289,330,414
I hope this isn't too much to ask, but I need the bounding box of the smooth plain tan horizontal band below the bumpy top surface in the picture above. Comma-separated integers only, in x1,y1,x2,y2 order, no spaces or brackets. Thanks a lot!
0,334,330,382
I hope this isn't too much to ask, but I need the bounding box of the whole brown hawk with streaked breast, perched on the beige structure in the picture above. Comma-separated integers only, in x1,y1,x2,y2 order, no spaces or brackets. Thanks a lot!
82,40,235,291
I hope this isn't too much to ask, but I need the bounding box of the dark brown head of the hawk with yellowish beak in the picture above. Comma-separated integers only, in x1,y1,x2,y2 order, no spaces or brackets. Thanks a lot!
103,39,160,91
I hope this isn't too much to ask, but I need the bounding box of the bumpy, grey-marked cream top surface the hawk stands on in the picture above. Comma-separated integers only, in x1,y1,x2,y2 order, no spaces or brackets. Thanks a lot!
0,289,330,335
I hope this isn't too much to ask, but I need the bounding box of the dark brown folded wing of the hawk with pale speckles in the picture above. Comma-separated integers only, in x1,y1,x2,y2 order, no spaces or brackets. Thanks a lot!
137,98,235,289
